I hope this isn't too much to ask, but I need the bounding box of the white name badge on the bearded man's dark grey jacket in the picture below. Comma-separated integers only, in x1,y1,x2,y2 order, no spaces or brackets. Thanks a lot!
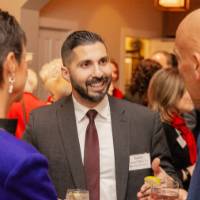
129,153,151,171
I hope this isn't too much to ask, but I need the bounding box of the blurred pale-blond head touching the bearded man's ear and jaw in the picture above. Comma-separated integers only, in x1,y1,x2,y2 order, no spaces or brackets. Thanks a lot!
39,58,72,104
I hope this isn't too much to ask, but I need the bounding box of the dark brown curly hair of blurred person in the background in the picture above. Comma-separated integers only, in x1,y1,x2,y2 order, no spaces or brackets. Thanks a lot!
125,59,162,106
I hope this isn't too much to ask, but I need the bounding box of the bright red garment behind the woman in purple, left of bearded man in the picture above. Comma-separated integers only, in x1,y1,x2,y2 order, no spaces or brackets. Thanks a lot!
7,92,46,138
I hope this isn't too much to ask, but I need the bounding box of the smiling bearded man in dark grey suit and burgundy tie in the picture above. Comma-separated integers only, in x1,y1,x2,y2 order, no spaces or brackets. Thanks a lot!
25,31,180,200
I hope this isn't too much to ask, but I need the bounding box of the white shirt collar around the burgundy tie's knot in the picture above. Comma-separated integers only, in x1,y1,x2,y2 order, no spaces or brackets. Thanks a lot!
72,95,110,122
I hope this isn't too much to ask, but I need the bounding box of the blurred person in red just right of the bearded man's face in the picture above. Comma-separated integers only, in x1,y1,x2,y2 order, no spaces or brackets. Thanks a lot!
108,59,124,99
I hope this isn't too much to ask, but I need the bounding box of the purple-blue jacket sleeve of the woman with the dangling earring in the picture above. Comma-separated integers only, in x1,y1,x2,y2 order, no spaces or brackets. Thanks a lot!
4,153,57,200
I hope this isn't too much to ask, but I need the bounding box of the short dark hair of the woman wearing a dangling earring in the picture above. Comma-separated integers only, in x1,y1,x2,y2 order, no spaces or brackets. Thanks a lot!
0,9,26,83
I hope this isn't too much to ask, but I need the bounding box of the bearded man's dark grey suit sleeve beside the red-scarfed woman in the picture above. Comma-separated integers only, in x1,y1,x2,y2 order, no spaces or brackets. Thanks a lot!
152,114,182,187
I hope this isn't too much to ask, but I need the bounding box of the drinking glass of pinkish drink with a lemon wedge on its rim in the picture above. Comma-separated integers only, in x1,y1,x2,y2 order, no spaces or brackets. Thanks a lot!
151,178,179,200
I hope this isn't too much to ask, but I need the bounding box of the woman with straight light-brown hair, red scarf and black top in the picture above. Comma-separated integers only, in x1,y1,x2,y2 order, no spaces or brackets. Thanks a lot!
148,68,197,190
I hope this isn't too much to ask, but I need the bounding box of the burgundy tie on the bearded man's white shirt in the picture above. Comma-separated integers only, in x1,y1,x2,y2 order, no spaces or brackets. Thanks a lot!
84,110,100,200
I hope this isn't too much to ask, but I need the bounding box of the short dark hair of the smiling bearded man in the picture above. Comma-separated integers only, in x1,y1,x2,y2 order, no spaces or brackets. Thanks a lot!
61,30,106,66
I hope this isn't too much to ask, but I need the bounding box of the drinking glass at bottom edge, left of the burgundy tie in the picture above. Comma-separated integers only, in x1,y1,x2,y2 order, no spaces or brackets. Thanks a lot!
66,189,89,200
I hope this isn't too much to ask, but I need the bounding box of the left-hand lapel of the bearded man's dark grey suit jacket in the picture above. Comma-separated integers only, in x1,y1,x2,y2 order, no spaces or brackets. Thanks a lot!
57,96,86,188
